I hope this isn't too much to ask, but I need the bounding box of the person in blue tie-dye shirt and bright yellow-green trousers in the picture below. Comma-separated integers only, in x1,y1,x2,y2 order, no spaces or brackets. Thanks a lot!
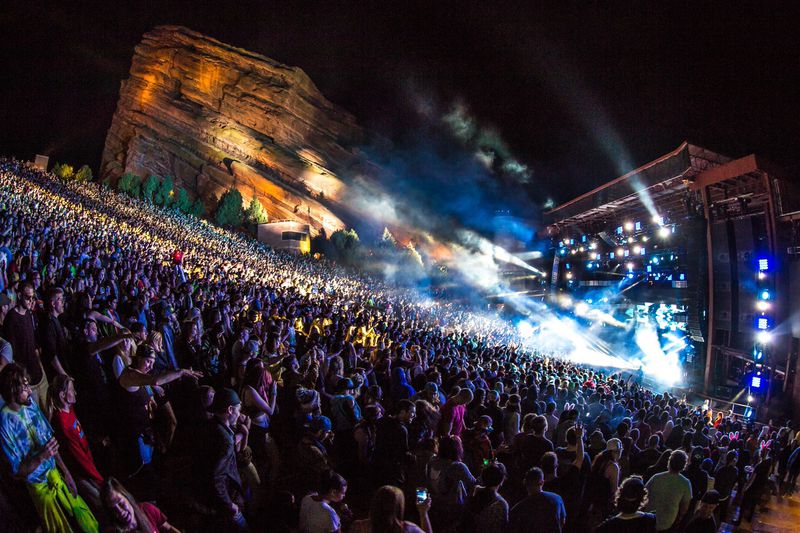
0,363,99,533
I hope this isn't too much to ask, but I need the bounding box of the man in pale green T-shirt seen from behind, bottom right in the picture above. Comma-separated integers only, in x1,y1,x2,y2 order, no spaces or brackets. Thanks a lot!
645,450,692,531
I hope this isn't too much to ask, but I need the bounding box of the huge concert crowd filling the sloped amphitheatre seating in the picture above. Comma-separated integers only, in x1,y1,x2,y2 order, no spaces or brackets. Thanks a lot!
0,159,800,533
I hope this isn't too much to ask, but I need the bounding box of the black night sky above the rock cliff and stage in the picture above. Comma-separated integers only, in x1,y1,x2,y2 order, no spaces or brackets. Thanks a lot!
0,0,800,201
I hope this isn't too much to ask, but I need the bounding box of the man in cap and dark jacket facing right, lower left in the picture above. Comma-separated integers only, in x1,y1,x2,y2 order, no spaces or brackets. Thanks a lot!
198,389,248,531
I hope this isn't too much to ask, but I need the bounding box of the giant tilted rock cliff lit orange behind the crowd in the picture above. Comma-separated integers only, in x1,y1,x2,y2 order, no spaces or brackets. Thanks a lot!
101,26,364,234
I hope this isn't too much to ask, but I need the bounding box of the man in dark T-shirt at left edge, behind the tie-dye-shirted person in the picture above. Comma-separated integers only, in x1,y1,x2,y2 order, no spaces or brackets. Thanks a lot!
3,282,47,411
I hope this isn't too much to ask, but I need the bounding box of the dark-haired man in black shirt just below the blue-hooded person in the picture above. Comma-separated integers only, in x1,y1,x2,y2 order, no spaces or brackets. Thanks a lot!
374,400,417,486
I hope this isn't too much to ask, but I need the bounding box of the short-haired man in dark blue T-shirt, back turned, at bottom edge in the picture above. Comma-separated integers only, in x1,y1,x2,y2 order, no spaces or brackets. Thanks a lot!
508,468,567,533
